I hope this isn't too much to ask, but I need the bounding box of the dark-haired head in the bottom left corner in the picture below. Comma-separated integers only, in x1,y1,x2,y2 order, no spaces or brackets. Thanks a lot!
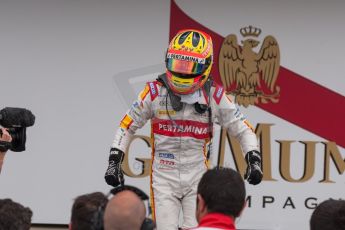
0,199,32,230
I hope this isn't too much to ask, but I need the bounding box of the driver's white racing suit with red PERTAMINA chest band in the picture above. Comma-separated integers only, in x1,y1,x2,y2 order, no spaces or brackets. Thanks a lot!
112,81,258,230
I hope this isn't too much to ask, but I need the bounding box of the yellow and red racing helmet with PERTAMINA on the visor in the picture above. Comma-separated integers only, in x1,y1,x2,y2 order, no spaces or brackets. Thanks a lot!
165,29,213,94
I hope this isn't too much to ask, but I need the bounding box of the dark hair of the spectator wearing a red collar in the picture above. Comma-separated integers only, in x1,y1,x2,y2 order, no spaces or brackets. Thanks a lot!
198,167,246,218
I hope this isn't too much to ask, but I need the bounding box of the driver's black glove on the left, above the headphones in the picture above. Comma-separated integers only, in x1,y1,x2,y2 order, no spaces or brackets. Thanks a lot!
104,148,125,187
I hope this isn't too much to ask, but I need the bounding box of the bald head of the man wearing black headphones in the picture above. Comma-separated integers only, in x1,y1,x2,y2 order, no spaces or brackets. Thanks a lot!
104,190,146,230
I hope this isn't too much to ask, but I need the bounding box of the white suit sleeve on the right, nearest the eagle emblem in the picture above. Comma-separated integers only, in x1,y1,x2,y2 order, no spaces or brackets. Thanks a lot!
213,86,259,153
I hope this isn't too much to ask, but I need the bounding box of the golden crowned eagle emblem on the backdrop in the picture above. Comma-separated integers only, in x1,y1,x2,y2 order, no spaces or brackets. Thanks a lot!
219,26,280,107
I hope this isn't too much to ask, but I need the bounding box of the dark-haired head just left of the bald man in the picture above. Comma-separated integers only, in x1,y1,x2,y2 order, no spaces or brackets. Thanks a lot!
69,192,108,230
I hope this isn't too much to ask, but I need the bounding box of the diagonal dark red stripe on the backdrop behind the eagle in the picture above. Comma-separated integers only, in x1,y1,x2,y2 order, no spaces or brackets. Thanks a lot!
170,0,345,147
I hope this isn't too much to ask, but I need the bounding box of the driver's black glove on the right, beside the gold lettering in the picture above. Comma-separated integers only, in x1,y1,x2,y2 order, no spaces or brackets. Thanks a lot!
244,150,263,185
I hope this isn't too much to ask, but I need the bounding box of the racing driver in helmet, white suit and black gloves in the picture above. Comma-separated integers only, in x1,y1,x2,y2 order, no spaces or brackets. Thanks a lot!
105,29,262,230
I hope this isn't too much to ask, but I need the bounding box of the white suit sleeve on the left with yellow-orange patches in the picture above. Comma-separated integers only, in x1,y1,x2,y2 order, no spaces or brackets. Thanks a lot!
111,84,152,152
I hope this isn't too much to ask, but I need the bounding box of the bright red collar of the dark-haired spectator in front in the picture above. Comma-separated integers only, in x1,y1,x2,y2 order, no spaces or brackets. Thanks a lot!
198,213,236,230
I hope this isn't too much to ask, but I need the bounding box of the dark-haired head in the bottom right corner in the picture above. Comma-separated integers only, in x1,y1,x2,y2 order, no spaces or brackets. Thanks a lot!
310,199,345,230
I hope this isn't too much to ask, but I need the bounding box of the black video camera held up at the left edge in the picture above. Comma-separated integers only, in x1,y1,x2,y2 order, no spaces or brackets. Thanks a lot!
0,107,35,152
